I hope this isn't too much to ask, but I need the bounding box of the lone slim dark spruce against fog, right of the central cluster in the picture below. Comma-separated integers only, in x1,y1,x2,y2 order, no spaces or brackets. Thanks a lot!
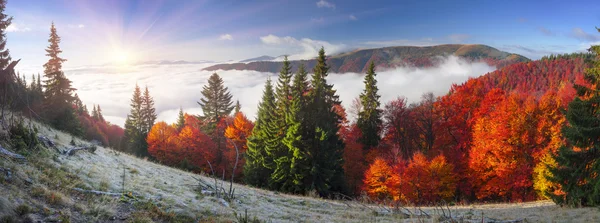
356,61,383,150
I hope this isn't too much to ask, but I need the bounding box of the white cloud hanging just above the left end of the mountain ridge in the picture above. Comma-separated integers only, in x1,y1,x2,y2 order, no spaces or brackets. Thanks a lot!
260,34,350,60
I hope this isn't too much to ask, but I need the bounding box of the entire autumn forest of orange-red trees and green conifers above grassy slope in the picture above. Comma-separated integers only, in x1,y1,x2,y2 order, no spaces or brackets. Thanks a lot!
0,0,600,211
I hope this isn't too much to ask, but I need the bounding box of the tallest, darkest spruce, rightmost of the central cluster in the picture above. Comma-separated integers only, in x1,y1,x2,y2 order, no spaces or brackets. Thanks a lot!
306,48,345,196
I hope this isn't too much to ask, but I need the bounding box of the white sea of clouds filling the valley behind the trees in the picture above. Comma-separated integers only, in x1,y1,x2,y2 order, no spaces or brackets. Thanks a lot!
58,56,496,126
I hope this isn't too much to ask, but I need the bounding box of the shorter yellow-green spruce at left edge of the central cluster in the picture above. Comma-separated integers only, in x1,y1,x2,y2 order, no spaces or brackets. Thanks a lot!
244,79,275,188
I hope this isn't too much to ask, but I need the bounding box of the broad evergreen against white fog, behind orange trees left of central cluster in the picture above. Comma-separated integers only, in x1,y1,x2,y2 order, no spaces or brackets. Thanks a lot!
198,73,233,134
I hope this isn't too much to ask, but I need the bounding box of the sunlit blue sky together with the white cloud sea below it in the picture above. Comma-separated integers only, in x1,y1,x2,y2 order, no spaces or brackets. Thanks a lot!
4,0,600,125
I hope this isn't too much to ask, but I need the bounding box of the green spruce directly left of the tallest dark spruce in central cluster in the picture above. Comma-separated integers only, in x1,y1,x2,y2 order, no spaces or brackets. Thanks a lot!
272,64,310,194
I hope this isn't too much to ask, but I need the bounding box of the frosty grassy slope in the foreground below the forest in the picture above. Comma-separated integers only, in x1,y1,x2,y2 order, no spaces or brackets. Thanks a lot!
0,117,600,222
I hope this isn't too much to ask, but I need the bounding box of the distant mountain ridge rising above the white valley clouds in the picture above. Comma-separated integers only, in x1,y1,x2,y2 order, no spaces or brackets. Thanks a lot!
203,44,530,73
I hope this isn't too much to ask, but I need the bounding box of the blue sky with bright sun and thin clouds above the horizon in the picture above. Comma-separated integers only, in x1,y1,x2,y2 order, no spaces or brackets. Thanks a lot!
5,0,600,70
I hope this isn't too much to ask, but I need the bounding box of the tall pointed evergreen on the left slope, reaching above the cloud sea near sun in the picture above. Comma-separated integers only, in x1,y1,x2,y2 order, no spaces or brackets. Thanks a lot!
43,23,82,135
